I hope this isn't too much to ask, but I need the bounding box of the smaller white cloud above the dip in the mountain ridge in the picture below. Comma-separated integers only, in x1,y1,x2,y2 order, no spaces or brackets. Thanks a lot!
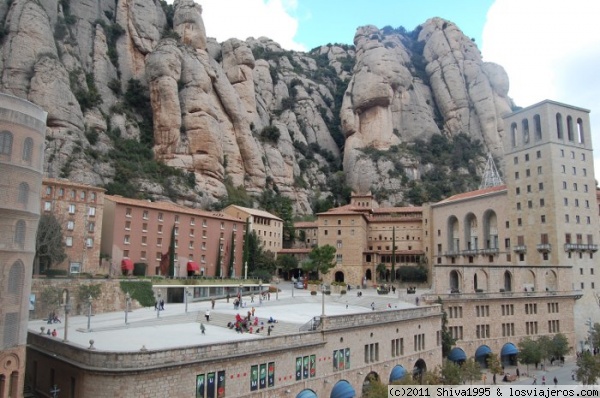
192,0,306,51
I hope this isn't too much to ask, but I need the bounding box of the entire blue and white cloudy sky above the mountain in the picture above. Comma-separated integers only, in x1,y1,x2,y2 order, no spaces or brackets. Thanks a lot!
168,0,600,179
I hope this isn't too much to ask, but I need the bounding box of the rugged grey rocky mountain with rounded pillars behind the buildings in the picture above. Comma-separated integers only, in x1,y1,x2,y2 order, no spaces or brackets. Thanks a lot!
0,0,512,214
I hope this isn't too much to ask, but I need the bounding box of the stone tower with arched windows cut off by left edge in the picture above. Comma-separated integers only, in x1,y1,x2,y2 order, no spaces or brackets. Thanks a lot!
0,94,47,398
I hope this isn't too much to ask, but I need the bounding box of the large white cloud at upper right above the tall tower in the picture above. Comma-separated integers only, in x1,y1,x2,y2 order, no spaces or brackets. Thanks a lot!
481,0,600,177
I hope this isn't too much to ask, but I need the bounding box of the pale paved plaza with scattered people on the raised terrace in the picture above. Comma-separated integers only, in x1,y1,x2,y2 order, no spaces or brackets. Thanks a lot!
29,284,425,351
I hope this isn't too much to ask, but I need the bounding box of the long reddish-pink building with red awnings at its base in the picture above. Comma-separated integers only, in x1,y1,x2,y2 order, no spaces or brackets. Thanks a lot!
101,195,244,277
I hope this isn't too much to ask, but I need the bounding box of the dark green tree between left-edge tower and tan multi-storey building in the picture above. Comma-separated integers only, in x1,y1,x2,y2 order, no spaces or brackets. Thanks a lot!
34,214,67,273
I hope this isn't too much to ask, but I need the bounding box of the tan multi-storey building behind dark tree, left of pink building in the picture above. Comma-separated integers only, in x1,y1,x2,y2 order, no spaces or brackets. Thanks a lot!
34,178,108,275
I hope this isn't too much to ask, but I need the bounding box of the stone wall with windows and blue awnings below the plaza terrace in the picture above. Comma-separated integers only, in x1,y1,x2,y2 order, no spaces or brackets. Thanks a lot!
27,305,441,398
